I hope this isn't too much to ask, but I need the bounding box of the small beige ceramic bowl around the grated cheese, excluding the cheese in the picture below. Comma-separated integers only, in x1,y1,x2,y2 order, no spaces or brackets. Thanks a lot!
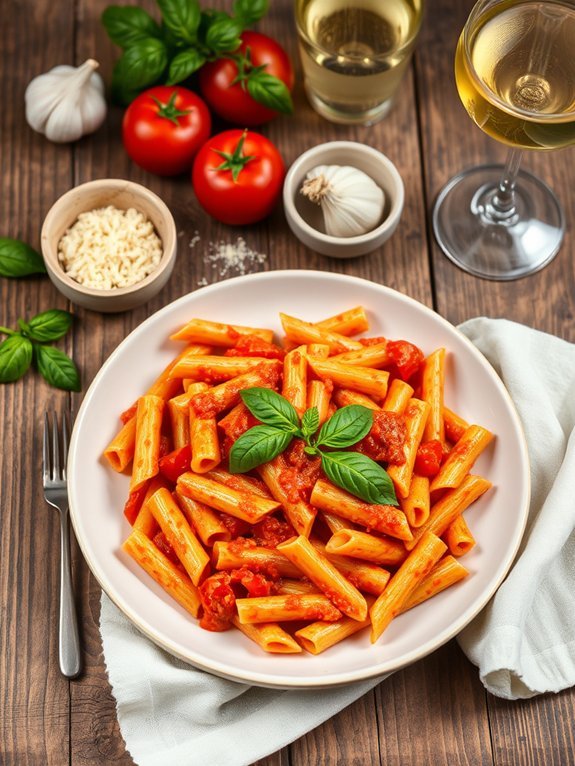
41,178,177,312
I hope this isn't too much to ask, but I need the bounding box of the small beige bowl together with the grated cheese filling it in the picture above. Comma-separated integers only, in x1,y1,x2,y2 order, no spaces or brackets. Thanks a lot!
41,178,177,312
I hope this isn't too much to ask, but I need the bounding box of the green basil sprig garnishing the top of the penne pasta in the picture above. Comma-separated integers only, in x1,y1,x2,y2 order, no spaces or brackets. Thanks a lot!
229,387,397,505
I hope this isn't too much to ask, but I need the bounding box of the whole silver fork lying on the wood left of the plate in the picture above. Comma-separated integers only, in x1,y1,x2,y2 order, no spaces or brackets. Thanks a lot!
42,411,82,678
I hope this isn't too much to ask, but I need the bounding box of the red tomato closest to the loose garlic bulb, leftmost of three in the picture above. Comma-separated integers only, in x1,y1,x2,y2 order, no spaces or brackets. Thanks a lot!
122,85,212,176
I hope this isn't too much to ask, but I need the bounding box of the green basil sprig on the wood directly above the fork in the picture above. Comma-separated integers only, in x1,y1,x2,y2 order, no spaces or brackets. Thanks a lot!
0,309,80,391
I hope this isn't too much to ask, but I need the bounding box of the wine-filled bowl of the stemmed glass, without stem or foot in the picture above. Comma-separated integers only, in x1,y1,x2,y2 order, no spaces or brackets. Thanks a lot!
455,0,575,149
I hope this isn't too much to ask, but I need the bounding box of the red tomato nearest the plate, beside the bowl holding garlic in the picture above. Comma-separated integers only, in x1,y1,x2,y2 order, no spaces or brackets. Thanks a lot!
192,130,285,225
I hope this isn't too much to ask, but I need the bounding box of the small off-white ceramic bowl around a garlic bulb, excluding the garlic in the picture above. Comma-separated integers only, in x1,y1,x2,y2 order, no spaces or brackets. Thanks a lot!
283,141,405,258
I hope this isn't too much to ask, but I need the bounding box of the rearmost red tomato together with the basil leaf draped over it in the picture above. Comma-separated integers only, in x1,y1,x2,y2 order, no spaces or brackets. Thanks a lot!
199,31,294,127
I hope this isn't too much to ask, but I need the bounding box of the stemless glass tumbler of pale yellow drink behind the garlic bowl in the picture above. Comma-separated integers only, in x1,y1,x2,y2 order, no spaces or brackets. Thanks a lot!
296,0,422,122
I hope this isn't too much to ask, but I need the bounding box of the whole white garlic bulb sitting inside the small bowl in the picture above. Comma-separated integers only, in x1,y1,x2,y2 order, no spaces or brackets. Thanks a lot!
301,165,384,237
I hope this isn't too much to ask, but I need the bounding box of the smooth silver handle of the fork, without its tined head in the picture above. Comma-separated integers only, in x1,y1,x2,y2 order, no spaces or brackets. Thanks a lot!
59,509,82,678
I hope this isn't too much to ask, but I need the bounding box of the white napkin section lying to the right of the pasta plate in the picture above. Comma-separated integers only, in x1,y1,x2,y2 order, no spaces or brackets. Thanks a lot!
458,318,575,699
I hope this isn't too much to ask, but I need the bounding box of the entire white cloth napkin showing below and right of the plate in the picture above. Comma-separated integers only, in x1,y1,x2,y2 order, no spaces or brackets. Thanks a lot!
100,318,575,766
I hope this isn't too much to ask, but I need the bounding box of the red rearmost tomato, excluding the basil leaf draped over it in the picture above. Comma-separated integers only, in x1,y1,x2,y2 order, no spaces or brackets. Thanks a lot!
199,31,294,126
